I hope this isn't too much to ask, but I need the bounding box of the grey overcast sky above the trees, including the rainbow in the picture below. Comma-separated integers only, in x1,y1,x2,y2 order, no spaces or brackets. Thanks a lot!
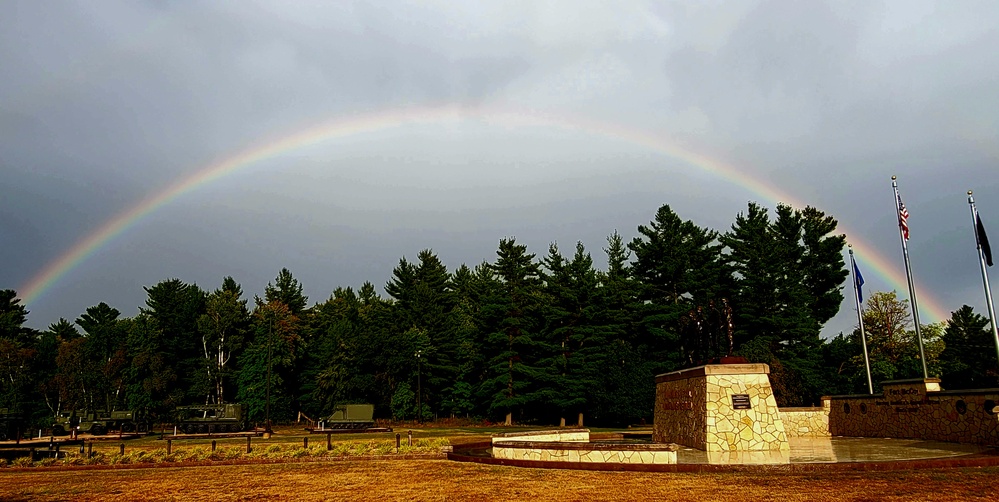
0,0,999,336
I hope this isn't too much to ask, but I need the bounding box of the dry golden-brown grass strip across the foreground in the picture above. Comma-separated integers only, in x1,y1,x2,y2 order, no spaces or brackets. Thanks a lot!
0,460,999,502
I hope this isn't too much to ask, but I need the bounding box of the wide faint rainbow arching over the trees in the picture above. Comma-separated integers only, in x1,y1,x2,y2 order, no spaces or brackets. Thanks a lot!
20,106,950,321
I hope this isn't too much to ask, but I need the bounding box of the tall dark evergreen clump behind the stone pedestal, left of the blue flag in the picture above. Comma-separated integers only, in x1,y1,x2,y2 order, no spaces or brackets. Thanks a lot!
721,202,847,406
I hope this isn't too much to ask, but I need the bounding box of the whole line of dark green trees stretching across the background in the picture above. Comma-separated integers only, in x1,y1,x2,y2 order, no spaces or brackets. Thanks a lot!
0,203,999,425
